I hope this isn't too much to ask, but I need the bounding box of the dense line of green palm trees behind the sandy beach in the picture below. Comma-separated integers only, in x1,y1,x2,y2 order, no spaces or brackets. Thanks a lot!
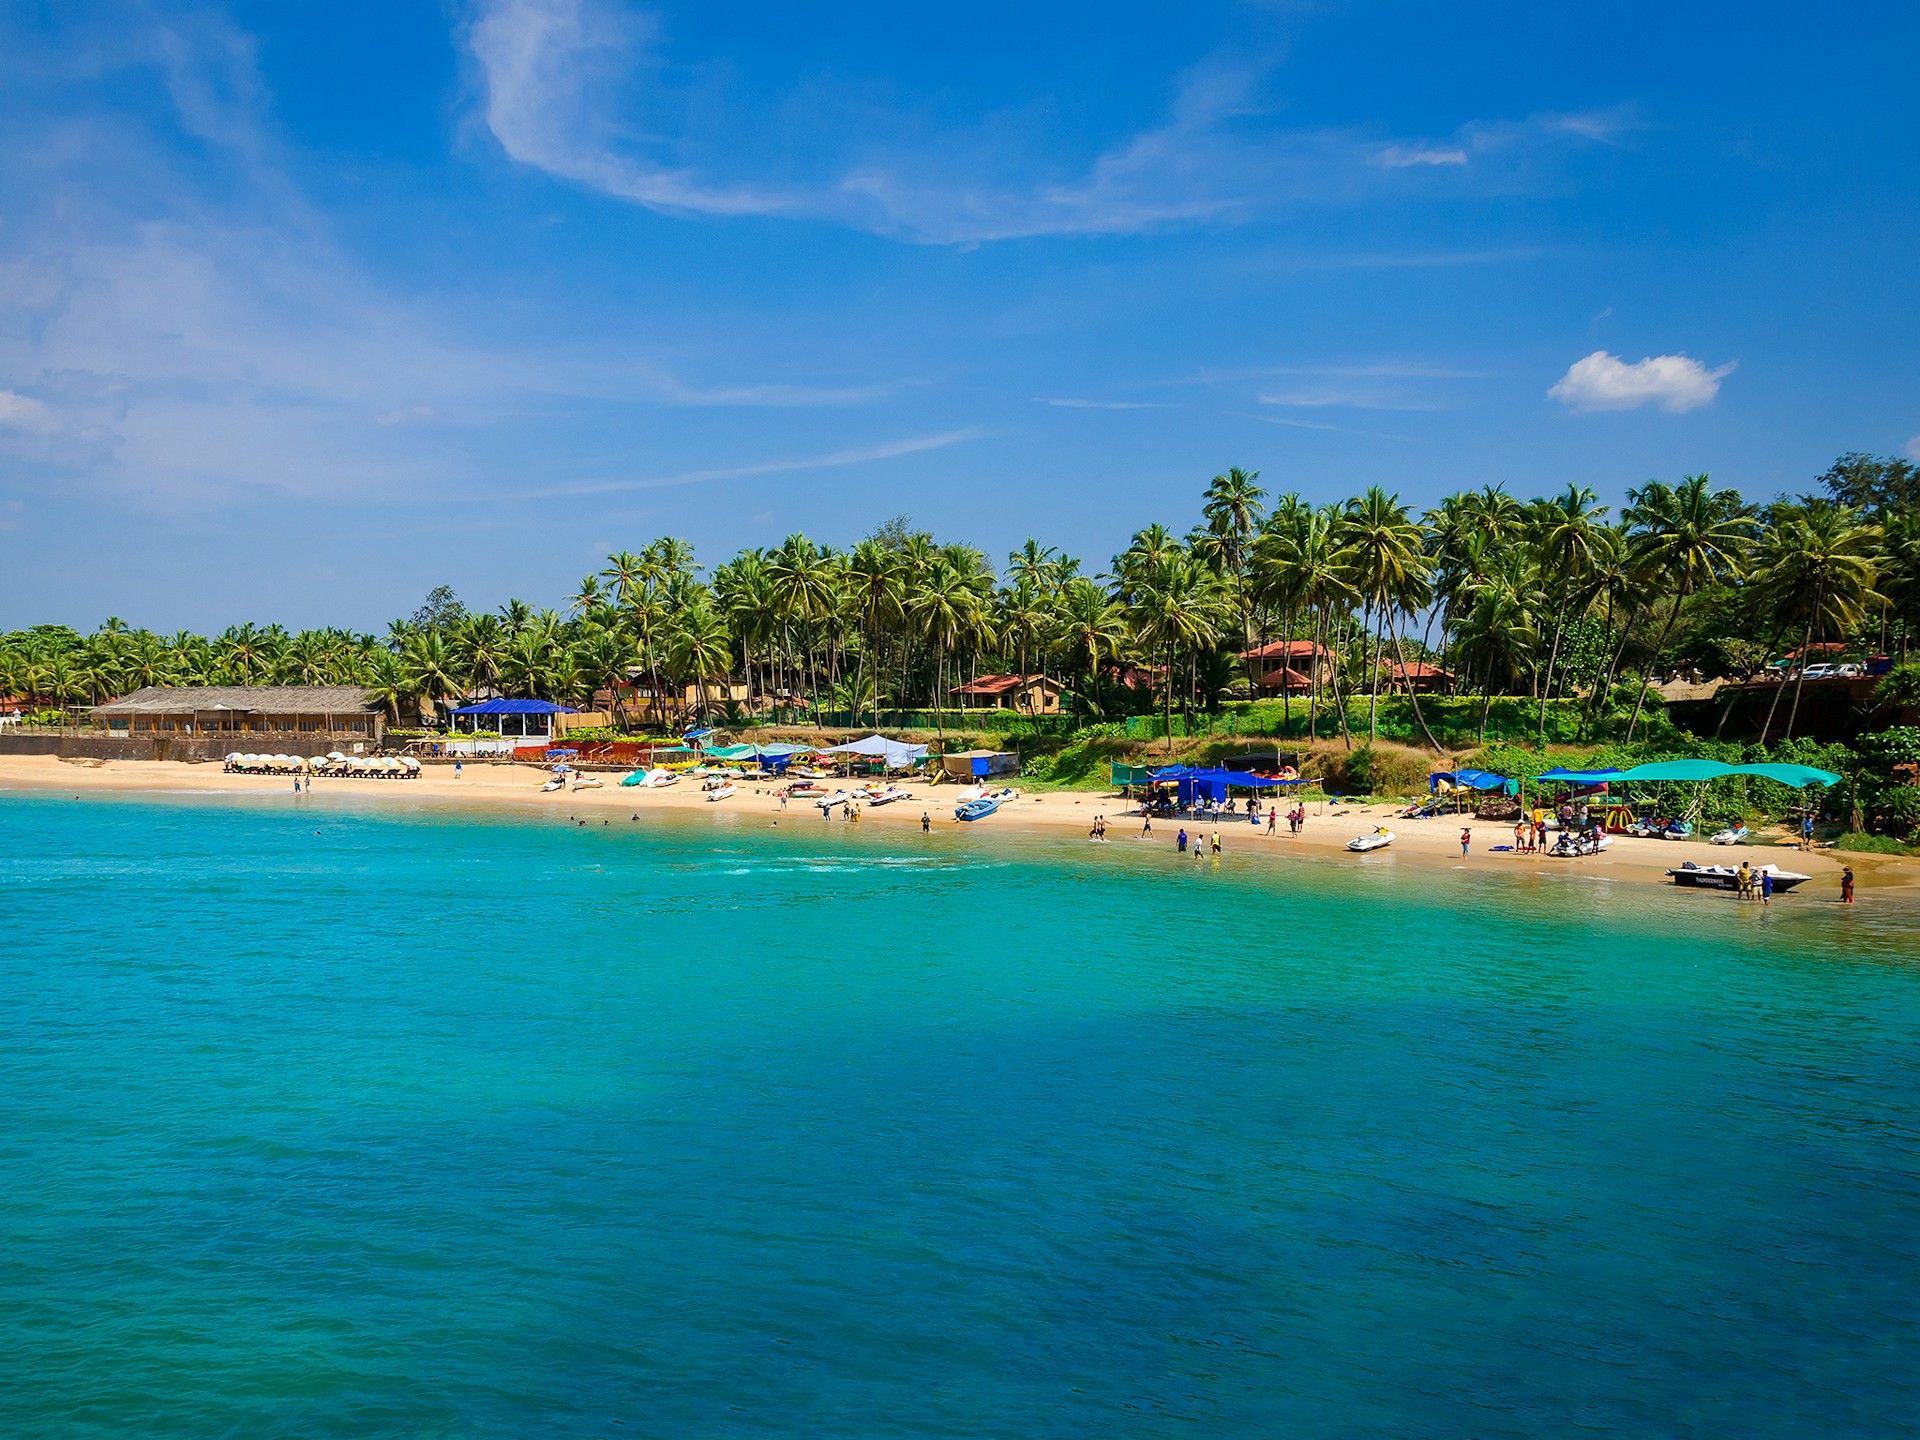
0,455,1920,739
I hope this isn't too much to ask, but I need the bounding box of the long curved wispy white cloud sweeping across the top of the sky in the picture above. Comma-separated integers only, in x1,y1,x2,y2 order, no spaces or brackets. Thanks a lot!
467,0,1635,244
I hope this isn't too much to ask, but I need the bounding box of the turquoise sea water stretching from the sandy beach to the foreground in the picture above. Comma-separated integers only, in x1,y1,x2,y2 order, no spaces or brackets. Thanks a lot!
0,797,1920,1436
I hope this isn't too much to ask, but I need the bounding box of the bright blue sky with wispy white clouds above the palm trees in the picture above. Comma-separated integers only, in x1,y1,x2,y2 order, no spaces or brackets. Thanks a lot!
0,0,1920,628
